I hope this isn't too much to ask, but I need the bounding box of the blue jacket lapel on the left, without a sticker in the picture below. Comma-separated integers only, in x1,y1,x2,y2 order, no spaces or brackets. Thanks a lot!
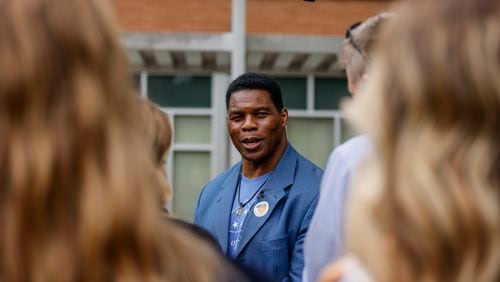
213,163,241,253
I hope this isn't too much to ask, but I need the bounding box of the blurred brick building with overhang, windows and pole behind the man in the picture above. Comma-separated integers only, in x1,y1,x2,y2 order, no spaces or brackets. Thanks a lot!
112,0,392,220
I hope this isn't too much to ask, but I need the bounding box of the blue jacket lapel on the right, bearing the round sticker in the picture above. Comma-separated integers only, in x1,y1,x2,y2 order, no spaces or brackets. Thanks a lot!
234,144,297,256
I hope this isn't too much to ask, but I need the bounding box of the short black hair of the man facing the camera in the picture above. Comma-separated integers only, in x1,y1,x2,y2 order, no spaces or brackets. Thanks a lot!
226,72,283,112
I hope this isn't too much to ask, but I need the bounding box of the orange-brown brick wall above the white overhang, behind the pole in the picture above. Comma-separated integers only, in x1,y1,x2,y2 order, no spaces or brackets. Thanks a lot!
113,0,391,35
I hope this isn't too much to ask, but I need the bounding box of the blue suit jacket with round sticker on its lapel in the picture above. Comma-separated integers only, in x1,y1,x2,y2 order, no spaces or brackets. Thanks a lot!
194,144,323,281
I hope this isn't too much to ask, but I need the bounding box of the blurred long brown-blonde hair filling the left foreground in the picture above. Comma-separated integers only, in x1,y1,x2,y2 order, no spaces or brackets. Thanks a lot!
0,0,222,281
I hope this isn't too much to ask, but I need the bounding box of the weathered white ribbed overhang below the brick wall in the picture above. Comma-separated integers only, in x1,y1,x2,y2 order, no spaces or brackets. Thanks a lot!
121,32,344,76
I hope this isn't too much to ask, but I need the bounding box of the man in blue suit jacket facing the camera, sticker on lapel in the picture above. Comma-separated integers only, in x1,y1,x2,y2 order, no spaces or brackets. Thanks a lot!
194,73,323,281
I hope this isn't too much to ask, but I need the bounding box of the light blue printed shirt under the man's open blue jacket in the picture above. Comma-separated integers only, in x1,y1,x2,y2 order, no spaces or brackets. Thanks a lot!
228,172,271,258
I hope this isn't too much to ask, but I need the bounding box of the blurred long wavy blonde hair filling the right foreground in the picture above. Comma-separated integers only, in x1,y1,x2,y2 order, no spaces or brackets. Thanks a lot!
346,0,500,281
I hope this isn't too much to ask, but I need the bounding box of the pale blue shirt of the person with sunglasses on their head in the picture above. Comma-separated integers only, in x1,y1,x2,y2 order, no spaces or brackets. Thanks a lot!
302,135,372,282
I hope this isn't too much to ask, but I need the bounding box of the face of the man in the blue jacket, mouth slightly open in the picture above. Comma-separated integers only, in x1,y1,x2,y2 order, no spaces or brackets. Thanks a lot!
227,89,288,163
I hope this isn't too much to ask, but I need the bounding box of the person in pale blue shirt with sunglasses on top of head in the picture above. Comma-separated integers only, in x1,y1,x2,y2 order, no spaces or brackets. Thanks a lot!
302,13,390,282
